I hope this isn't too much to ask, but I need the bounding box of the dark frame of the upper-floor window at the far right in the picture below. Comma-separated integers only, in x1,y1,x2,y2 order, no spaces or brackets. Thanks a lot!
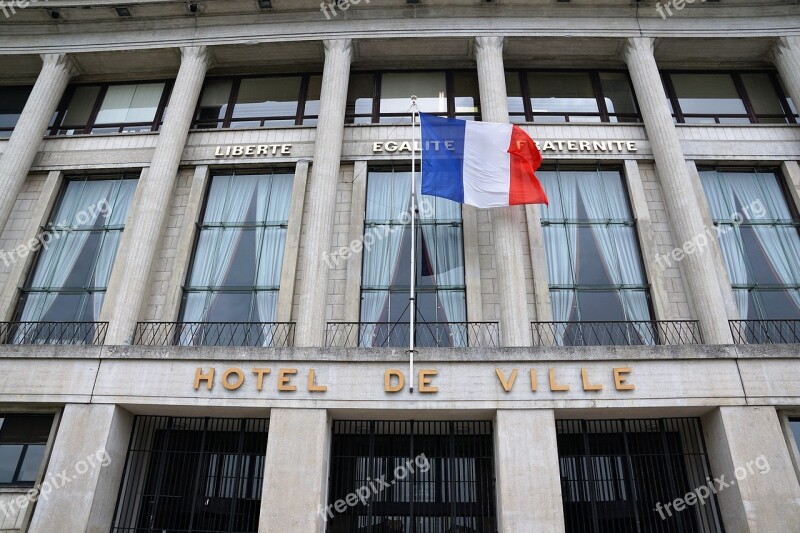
660,70,800,126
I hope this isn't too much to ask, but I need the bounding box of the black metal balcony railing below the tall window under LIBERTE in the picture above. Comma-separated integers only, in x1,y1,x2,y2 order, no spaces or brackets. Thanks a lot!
134,322,294,348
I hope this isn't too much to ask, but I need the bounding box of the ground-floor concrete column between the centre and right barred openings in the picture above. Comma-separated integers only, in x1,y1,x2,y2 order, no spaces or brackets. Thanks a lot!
494,409,564,533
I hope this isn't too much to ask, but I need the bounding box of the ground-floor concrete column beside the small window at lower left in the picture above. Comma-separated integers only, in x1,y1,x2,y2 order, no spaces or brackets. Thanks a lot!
28,404,133,533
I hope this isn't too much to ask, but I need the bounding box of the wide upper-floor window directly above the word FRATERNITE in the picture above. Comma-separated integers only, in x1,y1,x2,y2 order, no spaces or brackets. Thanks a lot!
506,71,641,123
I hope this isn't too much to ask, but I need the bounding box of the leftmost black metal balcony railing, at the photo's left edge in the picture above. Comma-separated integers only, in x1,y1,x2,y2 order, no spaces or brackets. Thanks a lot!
0,322,108,346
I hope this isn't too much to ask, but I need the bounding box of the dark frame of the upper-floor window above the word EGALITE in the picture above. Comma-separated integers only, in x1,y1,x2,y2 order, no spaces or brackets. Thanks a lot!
344,68,482,125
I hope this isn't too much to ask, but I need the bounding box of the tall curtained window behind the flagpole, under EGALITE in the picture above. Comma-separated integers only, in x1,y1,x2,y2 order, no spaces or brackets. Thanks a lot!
361,168,466,346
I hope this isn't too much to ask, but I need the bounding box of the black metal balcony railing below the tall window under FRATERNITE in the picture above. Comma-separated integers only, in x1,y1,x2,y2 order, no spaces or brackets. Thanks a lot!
531,320,703,346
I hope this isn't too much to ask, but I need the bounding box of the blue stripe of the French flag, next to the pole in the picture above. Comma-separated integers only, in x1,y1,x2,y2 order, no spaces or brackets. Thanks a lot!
420,113,467,204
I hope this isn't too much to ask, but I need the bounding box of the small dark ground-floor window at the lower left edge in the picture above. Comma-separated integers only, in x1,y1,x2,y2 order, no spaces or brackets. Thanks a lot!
0,414,53,487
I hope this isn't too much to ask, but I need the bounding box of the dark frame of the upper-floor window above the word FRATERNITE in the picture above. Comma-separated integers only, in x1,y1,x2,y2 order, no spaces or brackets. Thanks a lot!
505,68,643,122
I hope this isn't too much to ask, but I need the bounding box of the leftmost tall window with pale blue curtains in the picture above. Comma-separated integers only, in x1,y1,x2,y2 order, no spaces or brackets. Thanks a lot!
17,175,137,343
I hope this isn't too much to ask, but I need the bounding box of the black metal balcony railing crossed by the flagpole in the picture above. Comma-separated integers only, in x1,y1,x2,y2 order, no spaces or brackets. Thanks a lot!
325,322,500,348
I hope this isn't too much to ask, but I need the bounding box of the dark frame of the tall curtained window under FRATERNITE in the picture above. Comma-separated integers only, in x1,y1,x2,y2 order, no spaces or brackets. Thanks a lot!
540,162,656,324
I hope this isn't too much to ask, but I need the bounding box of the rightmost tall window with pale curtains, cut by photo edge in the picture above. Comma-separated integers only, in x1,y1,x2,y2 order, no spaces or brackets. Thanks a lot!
700,168,800,320
